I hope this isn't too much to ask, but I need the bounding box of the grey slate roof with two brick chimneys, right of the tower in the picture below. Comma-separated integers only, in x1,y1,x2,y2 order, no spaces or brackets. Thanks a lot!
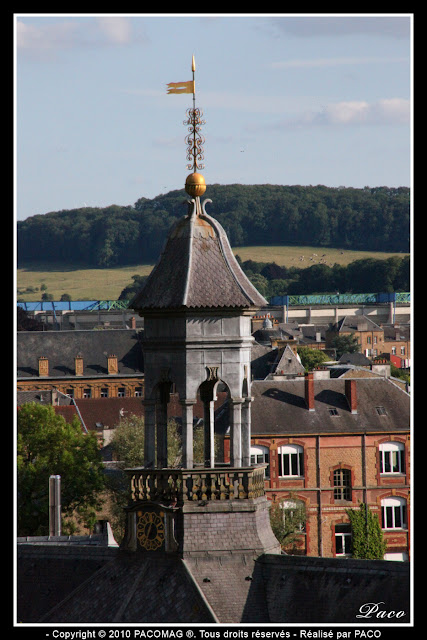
251,377,410,436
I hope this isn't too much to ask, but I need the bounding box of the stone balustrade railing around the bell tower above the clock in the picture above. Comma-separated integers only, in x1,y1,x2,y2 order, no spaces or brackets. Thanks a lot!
126,465,266,504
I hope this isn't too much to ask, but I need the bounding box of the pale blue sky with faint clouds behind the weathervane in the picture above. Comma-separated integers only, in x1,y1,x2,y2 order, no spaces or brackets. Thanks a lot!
14,13,413,220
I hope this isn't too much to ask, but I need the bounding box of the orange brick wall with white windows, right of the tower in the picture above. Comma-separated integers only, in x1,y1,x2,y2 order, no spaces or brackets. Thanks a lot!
224,433,410,557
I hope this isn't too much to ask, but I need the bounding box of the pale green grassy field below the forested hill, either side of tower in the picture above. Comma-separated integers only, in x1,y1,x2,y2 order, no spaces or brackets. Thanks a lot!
16,246,407,302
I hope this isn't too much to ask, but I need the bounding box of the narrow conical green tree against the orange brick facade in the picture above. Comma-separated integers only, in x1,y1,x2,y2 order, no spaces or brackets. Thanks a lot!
347,503,387,560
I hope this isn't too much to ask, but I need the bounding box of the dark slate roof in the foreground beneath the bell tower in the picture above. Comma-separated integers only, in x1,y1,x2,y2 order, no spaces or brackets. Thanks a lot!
17,544,411,626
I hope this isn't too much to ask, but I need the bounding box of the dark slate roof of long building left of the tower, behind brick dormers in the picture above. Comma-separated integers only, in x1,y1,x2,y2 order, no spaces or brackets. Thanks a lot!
17,329,144,378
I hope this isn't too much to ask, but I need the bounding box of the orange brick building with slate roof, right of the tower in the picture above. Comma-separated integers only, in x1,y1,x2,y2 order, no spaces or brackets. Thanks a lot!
225,371,410,560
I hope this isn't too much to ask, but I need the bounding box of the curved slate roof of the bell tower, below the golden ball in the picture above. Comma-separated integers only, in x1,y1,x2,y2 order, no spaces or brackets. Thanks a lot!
129,198,267,315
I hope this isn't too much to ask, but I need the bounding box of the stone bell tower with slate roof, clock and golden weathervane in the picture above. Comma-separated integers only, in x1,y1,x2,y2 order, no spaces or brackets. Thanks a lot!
124,56,280,556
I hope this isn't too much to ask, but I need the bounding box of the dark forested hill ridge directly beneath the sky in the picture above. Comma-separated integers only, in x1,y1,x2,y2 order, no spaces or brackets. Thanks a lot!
17,184,410,267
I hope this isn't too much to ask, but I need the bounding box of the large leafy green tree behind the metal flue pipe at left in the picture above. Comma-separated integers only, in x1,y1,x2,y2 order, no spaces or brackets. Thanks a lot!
17,402,104,536
